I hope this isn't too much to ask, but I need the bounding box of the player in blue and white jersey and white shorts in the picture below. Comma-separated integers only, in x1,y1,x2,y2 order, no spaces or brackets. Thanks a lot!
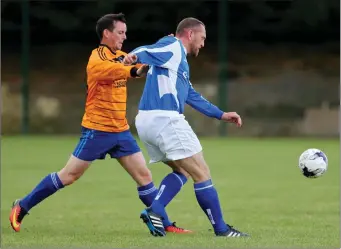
123,18,248,237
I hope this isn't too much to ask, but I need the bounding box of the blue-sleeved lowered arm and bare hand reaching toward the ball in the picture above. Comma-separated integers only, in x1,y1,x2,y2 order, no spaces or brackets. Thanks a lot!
186,84,242,127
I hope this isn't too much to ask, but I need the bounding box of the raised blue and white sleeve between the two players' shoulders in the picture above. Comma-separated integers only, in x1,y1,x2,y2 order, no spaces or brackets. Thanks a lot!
131,37,176,67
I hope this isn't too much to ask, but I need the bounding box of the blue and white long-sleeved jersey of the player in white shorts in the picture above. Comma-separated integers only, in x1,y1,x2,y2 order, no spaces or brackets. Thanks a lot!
131,36,223,119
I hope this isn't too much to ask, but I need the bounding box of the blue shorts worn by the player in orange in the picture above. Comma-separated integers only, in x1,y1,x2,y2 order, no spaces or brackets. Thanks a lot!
72,127,141,162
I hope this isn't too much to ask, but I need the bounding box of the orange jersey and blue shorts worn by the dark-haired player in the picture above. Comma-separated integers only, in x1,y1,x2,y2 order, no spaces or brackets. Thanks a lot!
73,44,140,161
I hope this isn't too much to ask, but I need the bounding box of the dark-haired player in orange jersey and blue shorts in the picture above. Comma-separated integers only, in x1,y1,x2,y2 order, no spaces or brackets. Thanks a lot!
10,13,191,233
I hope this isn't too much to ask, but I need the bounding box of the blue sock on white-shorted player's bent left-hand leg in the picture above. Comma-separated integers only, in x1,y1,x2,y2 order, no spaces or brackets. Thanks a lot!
151,172,187,226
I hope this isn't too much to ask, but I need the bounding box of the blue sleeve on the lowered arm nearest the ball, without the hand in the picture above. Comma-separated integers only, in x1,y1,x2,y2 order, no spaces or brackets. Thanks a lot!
186,83,224,119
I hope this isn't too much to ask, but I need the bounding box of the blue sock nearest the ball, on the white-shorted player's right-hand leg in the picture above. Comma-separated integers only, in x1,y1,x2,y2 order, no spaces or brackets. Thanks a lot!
194,180,229,233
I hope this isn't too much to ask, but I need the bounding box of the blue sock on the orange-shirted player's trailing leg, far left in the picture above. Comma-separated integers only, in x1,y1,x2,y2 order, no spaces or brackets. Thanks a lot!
20,173,64,212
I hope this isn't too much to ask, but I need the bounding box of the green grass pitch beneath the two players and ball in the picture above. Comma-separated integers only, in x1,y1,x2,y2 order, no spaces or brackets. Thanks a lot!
1,136,340,248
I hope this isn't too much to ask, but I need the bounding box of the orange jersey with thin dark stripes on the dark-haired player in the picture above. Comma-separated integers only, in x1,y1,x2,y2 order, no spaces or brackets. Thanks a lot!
82,45,137,132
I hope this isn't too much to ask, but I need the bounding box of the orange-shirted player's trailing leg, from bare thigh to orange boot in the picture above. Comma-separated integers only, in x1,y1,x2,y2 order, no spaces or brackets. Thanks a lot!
9,155,91,232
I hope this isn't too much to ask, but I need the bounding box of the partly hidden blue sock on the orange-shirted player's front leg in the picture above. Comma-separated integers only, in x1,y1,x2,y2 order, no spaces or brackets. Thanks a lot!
137,182,172,227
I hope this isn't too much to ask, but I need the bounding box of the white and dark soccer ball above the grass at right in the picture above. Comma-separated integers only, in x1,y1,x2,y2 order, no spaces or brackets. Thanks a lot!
298,149,328,178
